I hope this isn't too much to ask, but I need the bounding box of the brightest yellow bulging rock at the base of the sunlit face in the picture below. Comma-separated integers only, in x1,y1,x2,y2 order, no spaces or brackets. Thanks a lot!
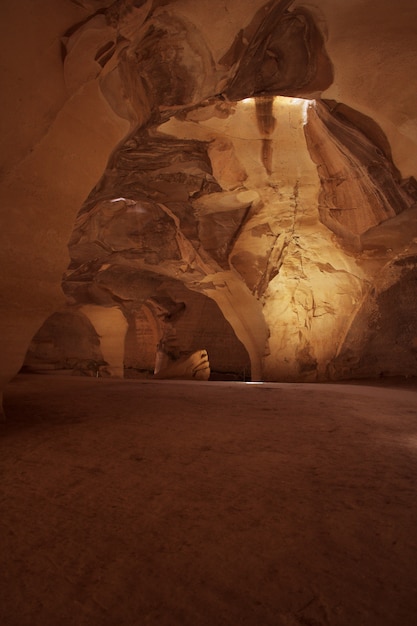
264,246,365,381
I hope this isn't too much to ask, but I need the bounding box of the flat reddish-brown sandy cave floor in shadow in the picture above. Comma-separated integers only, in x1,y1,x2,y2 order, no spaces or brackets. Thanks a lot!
0,375,417,626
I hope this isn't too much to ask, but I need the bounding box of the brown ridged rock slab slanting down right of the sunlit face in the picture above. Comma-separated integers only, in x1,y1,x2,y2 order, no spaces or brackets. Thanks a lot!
306,103,413,236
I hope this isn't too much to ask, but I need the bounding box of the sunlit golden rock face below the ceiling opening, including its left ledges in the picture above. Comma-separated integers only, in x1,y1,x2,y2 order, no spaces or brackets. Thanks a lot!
158,98,363,380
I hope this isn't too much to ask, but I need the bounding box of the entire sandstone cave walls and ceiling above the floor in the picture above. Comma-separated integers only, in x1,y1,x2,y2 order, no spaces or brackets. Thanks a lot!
1,0,417,402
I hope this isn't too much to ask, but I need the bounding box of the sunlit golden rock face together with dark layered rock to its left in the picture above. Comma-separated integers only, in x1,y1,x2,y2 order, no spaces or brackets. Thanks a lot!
57,97,364,380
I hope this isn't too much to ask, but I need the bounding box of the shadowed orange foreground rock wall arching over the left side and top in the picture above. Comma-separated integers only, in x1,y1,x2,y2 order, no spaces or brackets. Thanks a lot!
0,0,417,400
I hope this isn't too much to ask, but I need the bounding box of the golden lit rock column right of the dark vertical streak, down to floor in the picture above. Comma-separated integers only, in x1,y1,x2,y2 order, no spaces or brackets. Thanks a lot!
216,98,363,380
